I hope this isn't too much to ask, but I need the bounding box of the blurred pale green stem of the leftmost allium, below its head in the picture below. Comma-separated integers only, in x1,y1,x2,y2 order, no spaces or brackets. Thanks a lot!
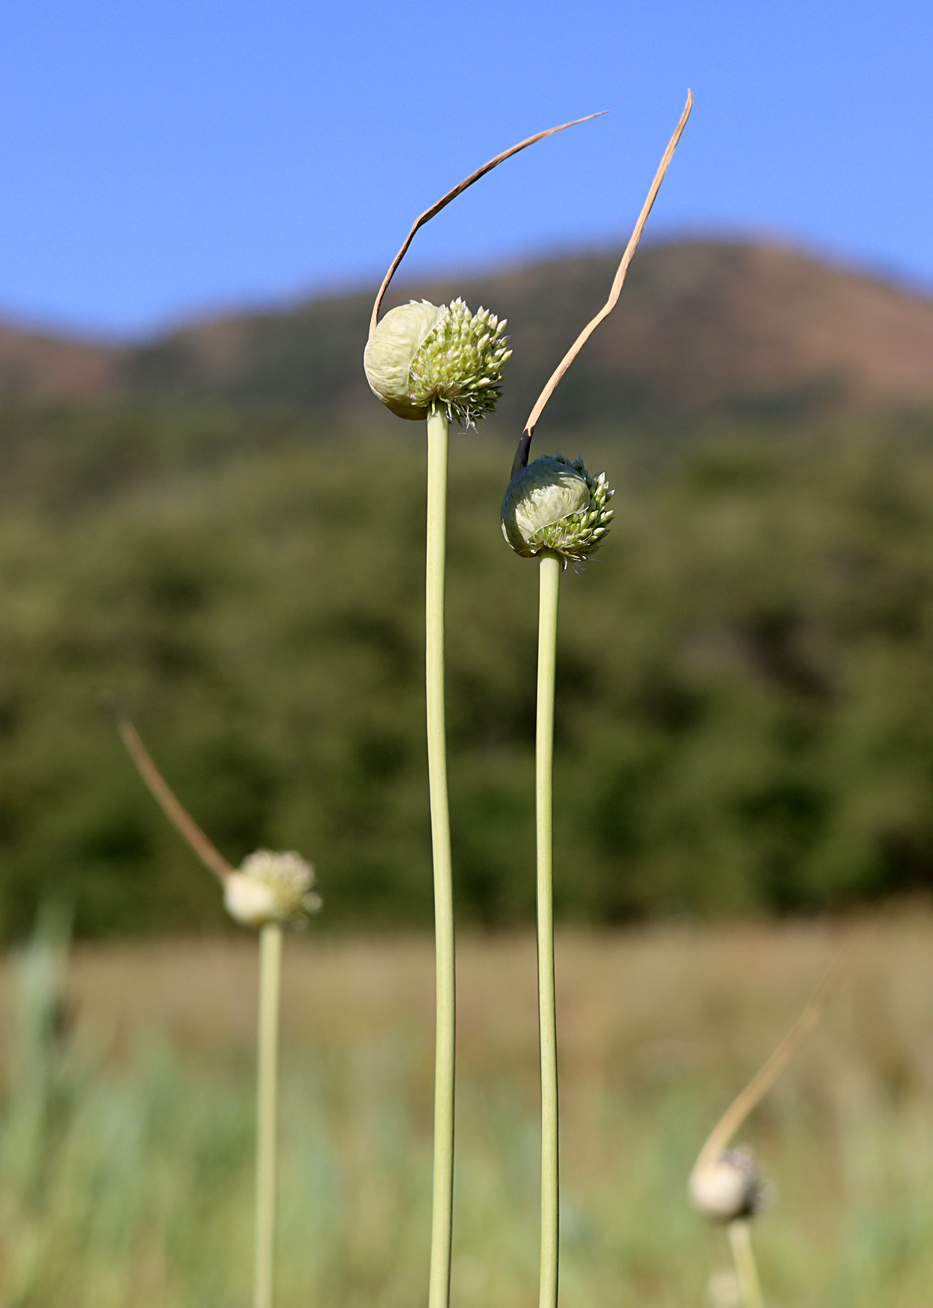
253,922,283,1308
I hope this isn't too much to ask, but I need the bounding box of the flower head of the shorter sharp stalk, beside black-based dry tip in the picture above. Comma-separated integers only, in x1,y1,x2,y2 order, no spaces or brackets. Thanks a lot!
502,454,614,566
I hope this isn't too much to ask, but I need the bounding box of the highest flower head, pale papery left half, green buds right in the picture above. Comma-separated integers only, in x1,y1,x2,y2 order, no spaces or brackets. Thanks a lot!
362,300,512,426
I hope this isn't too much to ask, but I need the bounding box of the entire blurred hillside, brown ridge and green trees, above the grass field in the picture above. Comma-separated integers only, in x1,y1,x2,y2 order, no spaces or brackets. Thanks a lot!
0,242,933,939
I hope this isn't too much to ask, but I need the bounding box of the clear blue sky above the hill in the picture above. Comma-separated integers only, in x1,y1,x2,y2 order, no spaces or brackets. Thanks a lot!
0,0,933,335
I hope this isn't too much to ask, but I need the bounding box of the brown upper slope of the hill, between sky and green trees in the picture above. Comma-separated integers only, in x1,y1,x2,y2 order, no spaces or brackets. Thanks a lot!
0,241,933,428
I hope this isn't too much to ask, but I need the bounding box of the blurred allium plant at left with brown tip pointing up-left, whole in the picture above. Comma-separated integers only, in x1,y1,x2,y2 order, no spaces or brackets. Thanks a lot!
114,709,321,1308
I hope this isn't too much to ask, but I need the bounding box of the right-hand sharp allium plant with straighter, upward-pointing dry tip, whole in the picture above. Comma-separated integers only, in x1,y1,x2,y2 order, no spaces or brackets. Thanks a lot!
501,92,694,1308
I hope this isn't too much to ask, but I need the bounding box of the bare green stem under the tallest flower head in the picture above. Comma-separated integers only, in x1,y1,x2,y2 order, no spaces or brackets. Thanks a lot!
425,405,455,1308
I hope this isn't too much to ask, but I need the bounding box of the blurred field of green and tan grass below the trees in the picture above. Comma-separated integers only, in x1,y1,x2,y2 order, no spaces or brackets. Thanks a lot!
0,909,933,1308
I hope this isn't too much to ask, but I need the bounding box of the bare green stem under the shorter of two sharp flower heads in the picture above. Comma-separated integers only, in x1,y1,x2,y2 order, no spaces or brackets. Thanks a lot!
535,553,561,1308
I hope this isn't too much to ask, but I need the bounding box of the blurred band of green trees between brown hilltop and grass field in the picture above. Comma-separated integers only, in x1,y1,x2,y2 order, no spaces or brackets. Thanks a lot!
0,387,933,938
